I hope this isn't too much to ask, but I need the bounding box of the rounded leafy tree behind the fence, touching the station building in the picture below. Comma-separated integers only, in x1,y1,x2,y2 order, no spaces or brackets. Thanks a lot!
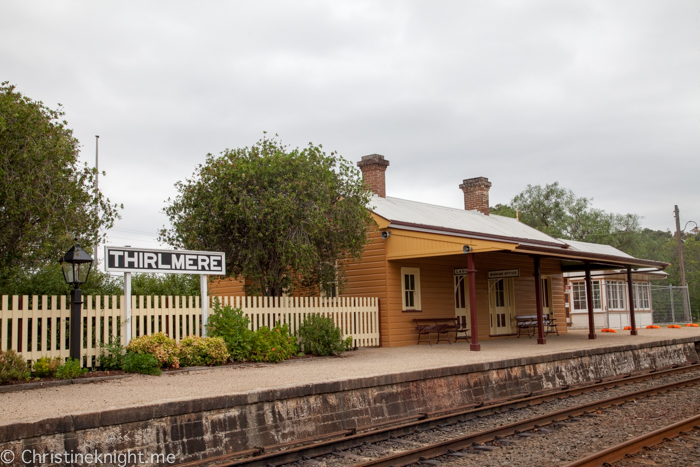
160,136,371,296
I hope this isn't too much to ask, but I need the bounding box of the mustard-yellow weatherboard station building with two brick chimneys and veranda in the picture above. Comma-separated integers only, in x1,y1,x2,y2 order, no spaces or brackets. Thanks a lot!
210,154,667,350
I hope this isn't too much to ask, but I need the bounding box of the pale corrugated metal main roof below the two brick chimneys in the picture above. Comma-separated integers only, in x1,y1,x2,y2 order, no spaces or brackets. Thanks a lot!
370,195,568,247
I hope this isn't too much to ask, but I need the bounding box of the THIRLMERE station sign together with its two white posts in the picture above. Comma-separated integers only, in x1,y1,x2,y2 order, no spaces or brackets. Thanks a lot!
105,246,226,344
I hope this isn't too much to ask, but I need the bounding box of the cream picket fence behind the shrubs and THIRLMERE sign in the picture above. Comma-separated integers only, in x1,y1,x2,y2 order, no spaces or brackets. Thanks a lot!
0,295,379,367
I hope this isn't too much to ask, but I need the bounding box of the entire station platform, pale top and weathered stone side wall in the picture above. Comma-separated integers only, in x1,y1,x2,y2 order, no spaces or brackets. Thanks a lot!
0,328,700,465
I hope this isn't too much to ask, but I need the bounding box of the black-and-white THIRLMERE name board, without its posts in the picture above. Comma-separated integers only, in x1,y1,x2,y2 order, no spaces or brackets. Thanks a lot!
105,246,226,275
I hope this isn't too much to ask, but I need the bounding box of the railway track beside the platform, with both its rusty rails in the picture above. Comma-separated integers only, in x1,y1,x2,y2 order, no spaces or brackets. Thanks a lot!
176,364,700,467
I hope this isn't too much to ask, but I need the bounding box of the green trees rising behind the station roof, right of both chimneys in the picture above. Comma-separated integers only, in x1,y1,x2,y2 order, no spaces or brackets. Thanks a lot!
491,182,640,252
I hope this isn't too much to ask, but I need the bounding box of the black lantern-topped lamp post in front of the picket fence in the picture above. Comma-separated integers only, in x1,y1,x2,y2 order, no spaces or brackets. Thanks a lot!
61,238,92,360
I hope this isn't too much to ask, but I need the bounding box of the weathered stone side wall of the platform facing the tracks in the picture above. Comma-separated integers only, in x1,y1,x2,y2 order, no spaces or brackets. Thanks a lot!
0,339,698,465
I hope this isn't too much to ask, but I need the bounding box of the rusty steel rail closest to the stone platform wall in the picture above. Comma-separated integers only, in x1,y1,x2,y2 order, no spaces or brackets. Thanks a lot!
179,362,700,467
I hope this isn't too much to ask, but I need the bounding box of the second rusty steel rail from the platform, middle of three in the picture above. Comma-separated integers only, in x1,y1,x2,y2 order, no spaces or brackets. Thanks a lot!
353,377,700,467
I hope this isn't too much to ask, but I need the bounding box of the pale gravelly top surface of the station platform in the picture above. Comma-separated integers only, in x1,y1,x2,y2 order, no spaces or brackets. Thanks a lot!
0,327,700,424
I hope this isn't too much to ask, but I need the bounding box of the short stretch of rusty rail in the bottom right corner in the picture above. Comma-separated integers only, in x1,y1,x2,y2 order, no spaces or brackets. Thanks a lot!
564,415,700,467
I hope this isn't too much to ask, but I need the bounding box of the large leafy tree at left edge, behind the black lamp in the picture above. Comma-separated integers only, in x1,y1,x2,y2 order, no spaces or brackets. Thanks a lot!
0,82,118,286
